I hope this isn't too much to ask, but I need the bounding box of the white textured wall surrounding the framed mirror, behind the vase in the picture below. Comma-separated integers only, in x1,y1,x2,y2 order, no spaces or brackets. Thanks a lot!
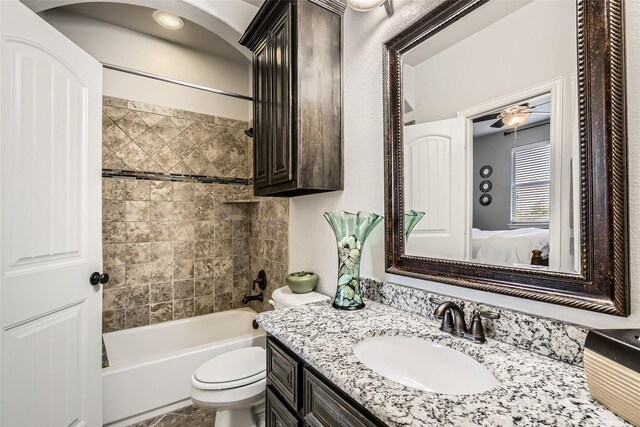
289,0,640,328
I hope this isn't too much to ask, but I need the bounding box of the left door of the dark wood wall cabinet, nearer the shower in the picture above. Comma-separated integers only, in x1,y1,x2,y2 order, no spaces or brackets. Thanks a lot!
253,39,273,188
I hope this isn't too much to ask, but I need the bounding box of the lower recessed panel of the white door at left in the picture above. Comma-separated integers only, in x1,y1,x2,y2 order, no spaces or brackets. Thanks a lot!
3,303,89,426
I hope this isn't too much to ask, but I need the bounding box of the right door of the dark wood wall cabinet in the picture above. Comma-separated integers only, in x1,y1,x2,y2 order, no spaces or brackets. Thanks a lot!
269,8,293,184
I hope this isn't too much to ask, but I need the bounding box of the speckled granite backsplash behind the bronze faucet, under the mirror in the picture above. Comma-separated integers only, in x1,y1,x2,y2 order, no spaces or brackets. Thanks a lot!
361,278,588,365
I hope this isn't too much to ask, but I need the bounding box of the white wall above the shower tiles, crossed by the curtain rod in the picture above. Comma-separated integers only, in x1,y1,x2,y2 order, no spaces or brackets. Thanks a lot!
41,10,252,120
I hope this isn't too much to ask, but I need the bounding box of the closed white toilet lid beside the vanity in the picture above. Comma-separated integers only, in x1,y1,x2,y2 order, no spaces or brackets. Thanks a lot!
194,347,267,387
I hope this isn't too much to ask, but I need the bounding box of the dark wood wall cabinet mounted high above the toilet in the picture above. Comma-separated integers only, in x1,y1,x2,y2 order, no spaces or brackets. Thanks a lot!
240,0,345,196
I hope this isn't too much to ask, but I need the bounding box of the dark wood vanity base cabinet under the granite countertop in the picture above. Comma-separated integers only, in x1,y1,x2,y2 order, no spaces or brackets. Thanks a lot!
266,336,385,427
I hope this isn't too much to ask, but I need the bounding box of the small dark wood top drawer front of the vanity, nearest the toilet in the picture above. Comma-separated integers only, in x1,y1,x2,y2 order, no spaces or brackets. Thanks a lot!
267,339,302,410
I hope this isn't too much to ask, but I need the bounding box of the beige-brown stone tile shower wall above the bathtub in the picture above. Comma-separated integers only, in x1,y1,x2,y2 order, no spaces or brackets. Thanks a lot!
103,97,288,332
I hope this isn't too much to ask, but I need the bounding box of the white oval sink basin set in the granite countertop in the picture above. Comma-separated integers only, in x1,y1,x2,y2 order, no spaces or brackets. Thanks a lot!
353,337,498,394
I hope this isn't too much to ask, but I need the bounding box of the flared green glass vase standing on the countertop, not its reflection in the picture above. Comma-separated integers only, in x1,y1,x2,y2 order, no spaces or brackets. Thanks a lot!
324,211,383,310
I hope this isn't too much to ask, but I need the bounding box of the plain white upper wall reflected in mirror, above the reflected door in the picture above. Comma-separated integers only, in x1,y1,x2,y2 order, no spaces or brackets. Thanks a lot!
405,1,577,123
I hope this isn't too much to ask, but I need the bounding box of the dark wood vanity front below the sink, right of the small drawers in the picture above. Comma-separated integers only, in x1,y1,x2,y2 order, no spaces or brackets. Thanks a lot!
303,368,377,427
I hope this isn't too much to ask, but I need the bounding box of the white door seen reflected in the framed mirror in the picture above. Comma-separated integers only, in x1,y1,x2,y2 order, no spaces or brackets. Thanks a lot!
404,117,469,260
